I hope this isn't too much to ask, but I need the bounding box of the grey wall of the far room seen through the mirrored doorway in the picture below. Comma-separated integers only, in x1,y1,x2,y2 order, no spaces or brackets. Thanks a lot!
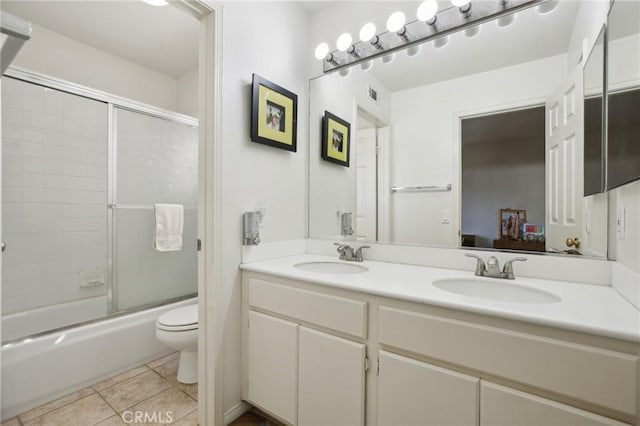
461,136,544,247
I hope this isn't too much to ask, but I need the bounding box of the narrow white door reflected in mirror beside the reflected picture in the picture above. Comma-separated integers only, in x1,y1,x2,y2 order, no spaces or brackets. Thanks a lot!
356,128,378,241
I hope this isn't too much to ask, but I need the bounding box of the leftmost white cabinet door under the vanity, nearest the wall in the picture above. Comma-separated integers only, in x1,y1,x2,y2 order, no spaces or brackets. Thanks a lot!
247,311,298,424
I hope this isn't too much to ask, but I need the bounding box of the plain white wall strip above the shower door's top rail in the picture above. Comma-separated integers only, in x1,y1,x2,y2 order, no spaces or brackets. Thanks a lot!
12,24,192,111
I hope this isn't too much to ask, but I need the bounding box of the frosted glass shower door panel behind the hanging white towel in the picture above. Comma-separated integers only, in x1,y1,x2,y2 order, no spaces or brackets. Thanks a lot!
109,108,198,312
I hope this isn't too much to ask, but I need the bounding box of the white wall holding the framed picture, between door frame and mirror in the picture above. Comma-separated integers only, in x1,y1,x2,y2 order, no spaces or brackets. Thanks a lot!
215,2,308,412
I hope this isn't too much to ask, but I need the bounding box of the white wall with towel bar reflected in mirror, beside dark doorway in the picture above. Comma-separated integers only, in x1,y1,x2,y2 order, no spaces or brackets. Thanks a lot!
391,55,566,246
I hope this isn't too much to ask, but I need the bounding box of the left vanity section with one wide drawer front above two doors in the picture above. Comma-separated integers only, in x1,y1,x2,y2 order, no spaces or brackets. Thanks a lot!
243,274,367,426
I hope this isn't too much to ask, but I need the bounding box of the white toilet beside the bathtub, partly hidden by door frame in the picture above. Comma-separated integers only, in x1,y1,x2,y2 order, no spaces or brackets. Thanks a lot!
156,304,198,383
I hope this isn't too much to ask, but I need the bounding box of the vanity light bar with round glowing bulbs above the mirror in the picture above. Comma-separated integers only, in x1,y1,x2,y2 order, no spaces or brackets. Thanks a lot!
316,0,559,73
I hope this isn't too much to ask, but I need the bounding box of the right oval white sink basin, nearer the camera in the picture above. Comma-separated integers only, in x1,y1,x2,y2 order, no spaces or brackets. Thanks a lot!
433,278,561,304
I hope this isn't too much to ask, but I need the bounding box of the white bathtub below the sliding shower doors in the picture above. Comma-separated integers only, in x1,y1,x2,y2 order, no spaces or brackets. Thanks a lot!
0,298,197,421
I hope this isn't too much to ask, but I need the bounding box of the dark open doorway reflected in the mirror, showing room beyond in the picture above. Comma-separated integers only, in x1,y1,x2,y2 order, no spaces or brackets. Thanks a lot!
461,106,545,251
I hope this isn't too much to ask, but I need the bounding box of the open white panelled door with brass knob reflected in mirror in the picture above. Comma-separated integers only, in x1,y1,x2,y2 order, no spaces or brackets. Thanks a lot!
545,65,584,251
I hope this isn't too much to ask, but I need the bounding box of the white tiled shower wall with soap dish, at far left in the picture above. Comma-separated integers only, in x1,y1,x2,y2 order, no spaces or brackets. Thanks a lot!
2,78,107,314
